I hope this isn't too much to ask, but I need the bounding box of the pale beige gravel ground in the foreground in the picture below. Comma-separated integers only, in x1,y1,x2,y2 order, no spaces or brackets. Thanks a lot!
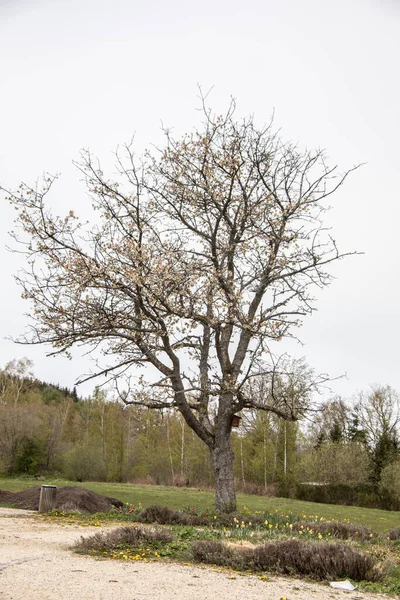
0,507,393,600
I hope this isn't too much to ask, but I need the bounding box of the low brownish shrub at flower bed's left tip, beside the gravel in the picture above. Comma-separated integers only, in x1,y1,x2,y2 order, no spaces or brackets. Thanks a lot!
73,526,174,551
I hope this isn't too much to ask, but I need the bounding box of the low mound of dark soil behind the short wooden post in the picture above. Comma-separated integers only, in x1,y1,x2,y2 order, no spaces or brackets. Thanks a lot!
0,486,124,514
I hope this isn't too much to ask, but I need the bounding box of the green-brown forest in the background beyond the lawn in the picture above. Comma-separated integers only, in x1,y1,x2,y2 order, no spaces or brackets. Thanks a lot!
0,359,400,510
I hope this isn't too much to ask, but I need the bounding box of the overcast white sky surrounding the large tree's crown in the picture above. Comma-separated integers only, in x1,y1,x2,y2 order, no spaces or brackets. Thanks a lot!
0,0,400,404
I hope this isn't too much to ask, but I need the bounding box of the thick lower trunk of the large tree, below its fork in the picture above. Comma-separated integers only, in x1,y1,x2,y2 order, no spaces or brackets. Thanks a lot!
211,437,236,513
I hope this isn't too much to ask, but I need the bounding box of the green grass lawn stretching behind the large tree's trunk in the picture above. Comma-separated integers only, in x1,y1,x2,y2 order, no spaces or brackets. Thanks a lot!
0,478,400,533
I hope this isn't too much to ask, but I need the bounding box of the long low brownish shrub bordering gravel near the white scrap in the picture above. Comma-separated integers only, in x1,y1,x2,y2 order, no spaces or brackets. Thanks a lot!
192,540,385,581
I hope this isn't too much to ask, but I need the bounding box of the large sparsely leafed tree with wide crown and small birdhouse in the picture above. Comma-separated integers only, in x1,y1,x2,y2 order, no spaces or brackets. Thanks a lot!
3,98,358,511
